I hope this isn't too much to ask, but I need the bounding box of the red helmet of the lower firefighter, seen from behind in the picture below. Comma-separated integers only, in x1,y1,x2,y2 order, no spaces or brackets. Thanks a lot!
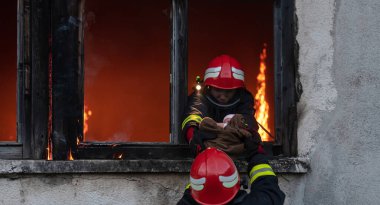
190,147,240,205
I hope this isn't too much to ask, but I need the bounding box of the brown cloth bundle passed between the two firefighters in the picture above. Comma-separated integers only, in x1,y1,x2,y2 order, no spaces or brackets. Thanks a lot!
199,114,252,157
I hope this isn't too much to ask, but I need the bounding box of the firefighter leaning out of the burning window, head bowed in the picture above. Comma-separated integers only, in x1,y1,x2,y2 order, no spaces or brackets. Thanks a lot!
182,55,258,155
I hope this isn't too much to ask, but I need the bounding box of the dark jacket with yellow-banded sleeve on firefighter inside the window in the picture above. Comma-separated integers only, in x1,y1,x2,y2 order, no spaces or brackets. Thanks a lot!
182,89,259,141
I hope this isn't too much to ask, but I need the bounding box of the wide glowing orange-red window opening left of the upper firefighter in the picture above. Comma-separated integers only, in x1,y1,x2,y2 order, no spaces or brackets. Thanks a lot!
84,0,170,142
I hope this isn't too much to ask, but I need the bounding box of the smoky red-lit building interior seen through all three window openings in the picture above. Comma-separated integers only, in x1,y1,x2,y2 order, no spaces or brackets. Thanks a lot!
0,0,274,142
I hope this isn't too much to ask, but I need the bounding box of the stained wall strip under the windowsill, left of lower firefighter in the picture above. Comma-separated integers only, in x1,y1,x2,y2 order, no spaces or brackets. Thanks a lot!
0,174,187,205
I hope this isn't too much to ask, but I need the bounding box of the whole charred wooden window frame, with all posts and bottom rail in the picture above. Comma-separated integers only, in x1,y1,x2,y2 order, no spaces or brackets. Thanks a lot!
0,0,302,160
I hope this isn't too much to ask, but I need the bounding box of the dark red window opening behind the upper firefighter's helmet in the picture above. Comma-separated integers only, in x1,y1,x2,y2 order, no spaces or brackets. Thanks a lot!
188,0,275,141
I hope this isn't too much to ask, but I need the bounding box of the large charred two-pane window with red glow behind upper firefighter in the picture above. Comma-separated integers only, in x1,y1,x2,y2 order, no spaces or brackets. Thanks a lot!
0,0,300,159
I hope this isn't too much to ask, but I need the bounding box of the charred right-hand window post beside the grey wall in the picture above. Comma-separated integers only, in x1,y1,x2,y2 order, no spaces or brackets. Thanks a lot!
273,0,302,157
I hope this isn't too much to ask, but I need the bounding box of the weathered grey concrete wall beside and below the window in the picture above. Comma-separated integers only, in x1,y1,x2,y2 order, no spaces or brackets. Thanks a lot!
0,0,380,205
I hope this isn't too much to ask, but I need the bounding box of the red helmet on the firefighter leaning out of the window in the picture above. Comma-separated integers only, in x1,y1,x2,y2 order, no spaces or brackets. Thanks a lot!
204,55,244,89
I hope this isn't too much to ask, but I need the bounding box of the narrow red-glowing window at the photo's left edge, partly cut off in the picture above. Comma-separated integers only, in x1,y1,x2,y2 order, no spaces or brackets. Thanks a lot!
0,0,28,159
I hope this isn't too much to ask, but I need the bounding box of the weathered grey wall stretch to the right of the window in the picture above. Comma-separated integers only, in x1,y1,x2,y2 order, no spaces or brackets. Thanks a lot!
296,0,380,204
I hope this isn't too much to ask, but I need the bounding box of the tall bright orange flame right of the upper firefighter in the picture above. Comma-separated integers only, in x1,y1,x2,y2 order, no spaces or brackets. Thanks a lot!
255,44,271,141
